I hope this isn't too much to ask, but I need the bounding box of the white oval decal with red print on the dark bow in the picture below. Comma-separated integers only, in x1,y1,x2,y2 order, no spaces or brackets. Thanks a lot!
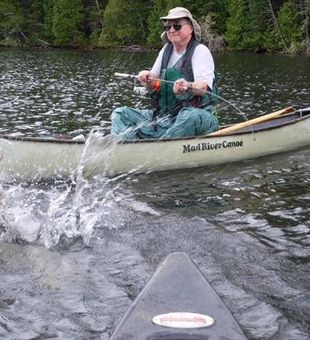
152,312,215,328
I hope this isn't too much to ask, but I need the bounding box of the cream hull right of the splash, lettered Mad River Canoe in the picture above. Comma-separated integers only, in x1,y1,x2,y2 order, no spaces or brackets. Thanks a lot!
88,110,310,175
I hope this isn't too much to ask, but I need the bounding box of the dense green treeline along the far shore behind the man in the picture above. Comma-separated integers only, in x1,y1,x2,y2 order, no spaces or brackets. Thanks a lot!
0,0,310,55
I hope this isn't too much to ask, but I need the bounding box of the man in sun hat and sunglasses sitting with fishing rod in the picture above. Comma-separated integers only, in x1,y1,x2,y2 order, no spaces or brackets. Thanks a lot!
111,7,218,140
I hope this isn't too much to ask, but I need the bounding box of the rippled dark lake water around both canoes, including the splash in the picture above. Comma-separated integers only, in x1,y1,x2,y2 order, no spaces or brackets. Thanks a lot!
0,49,310,340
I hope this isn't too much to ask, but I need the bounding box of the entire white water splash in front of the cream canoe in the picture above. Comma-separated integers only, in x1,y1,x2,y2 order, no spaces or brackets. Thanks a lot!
0,131,121,248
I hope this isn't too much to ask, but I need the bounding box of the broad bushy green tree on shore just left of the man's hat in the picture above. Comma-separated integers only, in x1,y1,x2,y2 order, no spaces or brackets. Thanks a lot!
99,0,150,47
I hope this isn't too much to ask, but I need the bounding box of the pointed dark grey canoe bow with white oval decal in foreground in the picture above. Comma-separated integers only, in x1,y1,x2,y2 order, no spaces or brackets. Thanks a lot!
110,253,246,340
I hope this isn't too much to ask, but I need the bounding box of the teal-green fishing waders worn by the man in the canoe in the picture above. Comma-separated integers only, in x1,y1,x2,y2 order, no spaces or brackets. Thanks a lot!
111,65,218,140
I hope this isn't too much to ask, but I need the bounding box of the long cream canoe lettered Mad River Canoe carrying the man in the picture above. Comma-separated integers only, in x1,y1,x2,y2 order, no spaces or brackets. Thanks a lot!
0,108,310,178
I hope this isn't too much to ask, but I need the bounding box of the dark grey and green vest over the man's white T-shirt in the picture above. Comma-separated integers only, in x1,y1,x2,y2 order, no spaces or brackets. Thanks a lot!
152,39,217,120
